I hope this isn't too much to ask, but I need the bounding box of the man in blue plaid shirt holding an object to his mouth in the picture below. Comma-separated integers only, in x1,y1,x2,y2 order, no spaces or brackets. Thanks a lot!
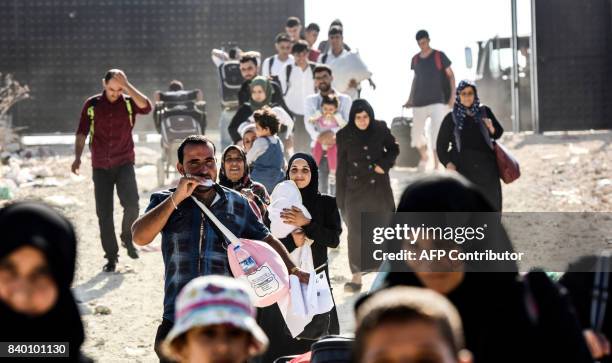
132,135,309,360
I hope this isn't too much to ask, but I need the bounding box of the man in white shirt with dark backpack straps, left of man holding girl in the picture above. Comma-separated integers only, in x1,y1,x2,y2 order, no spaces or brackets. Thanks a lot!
278,40,315,153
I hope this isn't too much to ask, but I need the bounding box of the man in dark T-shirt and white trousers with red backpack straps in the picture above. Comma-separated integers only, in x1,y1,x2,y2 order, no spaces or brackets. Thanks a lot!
404,30,455,170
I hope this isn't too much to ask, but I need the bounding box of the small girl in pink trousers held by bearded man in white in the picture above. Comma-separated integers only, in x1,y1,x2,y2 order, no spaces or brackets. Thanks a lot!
310,94,346,174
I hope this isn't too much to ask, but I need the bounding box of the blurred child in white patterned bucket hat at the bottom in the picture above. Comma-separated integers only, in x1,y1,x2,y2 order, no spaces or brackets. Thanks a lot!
164,276,268,363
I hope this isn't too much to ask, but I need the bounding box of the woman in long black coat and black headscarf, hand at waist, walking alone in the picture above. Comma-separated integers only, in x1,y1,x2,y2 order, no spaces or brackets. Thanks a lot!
336,99,399,292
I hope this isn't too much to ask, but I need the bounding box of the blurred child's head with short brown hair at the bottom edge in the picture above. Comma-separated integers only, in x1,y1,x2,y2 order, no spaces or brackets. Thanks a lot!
353,286,472,363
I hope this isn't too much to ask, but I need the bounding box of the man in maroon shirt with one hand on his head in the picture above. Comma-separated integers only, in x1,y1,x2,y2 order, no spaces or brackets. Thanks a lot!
72,69,151,272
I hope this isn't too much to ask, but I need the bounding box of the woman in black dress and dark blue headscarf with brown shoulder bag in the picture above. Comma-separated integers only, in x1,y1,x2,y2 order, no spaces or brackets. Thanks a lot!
436,80,504,211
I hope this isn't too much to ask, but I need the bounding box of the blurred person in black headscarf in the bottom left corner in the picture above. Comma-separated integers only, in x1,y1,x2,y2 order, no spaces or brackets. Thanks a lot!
0,202,92,362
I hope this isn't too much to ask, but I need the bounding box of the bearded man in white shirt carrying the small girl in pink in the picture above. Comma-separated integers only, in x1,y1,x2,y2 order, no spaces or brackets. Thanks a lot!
304,64,353,195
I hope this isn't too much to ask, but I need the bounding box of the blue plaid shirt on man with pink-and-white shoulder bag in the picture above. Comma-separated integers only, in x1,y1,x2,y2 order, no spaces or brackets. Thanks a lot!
146,184,270,321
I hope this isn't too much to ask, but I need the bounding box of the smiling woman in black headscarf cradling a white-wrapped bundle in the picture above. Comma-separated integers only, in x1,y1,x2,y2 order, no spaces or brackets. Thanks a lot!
257,153,342,362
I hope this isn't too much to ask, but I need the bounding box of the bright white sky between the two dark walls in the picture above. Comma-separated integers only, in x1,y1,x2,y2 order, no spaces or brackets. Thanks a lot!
305,0,531,122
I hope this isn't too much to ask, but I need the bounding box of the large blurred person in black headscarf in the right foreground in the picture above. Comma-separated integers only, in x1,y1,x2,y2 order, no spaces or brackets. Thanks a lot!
376,173,592,363
